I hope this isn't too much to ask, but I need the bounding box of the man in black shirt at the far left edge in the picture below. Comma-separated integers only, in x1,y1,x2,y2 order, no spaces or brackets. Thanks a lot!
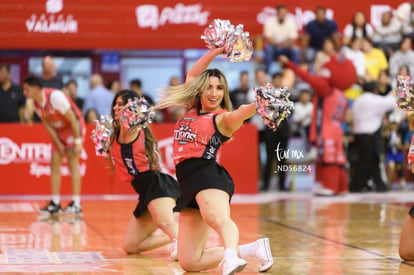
0,64,26,122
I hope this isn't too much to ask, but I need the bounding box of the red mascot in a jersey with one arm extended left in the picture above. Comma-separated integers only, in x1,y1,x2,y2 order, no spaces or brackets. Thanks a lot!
279,55,357,196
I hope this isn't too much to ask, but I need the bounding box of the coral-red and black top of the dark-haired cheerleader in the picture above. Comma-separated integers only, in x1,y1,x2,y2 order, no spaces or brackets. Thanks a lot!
111,129,151,183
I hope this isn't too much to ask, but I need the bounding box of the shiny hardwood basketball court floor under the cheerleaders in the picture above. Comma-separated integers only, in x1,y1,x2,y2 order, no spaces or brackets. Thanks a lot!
0,191,414,275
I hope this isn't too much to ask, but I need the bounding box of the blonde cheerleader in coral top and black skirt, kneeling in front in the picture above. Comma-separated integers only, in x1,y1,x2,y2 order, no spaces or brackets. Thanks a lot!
158,48,273,274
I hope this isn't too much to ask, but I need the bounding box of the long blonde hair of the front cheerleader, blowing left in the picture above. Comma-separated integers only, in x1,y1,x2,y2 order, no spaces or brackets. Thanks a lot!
156,69,232,111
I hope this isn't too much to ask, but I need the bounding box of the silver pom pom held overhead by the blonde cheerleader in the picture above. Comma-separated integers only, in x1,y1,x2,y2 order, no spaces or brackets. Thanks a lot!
201,19,253,62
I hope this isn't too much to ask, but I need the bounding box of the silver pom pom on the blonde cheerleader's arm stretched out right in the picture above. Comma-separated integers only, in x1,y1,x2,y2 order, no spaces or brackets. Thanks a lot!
255,83,294,131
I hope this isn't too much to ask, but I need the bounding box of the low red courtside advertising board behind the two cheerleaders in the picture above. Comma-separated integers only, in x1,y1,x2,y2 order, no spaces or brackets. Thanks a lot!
0,124,258,195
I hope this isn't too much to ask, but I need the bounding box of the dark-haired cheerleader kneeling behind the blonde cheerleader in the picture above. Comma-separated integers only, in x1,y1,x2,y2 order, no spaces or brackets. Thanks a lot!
110,90,180,260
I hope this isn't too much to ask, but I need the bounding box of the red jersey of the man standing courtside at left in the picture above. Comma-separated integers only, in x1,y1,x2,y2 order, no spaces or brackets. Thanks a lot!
35,88,85,132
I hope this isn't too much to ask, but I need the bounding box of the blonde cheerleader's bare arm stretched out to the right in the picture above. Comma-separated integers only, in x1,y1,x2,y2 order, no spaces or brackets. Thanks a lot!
216,103,256,137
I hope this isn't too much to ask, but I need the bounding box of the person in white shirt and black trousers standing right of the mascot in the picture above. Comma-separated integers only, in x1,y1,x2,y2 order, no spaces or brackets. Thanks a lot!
349,82,395,193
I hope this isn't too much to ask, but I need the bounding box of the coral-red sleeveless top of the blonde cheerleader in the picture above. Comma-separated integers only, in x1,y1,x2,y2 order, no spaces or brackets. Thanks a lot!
173,109,229,165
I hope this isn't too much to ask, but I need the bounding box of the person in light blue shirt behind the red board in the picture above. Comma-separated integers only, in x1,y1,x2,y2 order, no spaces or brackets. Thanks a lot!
83,74,115,116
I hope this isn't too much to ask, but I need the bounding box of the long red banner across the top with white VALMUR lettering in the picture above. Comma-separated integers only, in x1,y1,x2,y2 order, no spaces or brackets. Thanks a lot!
0,0,406,49
